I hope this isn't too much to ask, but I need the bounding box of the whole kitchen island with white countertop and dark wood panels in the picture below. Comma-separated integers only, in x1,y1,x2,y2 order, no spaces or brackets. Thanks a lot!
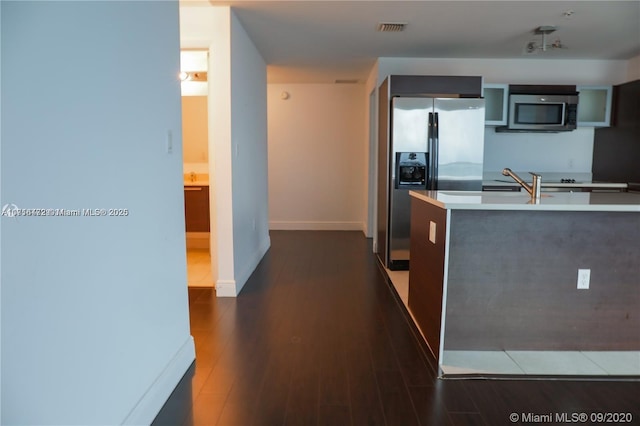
409,191,640,374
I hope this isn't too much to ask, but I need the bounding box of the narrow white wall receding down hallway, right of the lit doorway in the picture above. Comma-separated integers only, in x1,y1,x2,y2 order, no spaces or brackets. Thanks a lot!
231,13,271,294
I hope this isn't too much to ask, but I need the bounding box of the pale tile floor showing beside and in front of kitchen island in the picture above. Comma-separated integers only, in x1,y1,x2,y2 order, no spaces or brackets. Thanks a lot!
387,270,640,377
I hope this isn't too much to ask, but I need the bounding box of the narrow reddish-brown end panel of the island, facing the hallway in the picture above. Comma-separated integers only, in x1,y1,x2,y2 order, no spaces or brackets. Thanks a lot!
409,197,447,359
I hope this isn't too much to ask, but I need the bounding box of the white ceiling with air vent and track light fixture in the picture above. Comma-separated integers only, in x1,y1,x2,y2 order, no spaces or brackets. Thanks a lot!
194,0,640,83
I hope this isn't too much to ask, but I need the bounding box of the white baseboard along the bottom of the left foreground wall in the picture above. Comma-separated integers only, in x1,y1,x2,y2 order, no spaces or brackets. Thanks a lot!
122,336,196,426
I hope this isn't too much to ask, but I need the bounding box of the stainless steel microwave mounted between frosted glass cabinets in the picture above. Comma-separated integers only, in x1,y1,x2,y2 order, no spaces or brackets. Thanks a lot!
507,93,578,132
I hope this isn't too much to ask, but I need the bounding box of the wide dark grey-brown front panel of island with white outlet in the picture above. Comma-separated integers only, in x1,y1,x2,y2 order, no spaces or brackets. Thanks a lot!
445,210,640,350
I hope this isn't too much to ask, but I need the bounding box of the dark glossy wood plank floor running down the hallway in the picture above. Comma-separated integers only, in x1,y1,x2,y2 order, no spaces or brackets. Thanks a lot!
153,231,640,426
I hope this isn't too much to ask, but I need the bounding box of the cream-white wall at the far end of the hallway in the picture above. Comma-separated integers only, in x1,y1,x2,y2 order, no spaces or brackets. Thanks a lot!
267,84,368,232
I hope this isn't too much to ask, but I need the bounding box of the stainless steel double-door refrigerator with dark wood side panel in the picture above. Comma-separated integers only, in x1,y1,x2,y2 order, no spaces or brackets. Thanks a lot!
376,91,485,269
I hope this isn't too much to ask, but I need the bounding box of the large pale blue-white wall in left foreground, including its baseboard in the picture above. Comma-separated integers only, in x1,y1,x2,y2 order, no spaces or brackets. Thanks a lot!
0,1,194,425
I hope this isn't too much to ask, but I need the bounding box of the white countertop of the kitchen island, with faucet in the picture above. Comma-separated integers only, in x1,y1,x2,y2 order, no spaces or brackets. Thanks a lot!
409,191,640,212
